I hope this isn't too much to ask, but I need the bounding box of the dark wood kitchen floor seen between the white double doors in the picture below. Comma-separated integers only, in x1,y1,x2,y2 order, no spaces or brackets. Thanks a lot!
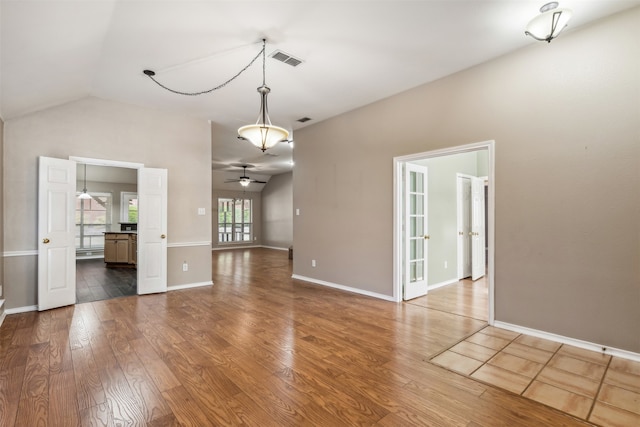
76,258,137,303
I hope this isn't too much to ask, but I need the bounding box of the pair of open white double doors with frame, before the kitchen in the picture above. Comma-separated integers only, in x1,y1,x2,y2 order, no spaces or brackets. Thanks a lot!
38,156,168,311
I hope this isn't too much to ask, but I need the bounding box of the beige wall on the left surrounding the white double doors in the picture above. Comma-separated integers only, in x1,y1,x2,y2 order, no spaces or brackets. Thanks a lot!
3,98,211,308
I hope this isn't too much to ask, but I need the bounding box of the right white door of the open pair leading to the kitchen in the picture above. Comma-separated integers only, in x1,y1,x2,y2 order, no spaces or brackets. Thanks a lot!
138,168,167,295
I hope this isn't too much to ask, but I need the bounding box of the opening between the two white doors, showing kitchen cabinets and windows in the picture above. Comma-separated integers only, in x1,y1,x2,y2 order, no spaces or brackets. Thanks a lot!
76,162,138,303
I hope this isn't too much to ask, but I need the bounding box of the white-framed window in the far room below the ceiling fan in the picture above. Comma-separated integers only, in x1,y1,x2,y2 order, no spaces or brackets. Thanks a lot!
218,199,253,243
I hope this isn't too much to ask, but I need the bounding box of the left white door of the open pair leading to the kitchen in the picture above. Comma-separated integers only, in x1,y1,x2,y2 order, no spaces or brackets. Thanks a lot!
38,157,76,311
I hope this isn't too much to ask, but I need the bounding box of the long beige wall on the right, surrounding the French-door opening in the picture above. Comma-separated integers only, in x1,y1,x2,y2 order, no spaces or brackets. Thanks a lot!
293,8,640,352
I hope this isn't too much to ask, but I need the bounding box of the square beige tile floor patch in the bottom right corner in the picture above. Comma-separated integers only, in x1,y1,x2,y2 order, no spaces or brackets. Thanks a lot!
431,326,640,427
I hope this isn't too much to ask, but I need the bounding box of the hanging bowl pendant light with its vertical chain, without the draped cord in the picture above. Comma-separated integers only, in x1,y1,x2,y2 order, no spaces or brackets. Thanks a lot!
238,39,289,151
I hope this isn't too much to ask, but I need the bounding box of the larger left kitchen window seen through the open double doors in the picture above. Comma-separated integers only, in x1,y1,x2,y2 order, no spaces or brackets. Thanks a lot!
76,193,111,251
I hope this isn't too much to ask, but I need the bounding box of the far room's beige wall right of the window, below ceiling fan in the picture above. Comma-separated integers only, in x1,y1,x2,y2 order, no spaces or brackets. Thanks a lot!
262,172,293,249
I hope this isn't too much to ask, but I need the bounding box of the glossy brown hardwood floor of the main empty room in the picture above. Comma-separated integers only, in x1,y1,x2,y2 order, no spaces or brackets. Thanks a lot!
0,249,590,427
